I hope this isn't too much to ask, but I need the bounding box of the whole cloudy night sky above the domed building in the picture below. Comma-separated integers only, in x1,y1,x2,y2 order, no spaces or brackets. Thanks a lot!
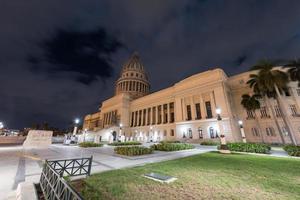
0,0,300,128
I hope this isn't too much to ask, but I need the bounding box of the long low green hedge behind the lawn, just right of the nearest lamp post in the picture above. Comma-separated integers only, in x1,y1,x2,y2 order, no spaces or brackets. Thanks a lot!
227,142,271,154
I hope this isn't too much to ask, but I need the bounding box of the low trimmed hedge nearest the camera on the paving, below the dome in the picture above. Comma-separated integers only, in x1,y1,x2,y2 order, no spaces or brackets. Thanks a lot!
114,146,153,156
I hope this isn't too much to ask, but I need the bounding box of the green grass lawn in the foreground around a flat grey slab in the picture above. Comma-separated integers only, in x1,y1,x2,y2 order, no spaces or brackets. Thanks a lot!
73,153,300,200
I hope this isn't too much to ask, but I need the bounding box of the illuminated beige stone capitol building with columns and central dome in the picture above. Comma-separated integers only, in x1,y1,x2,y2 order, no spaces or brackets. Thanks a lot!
83,53,300,143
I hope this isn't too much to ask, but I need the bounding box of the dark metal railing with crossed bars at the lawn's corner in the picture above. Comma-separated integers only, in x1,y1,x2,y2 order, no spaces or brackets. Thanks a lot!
40,157,93,200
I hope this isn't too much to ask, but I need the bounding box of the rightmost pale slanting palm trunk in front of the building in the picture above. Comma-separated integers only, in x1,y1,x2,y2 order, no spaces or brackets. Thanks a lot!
274,84,297,145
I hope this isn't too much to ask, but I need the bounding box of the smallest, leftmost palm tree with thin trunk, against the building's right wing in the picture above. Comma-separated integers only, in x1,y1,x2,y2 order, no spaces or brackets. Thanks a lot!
241,94,265,143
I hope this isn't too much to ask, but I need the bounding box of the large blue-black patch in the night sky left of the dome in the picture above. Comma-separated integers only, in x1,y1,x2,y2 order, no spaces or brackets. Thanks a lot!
28,28,123,84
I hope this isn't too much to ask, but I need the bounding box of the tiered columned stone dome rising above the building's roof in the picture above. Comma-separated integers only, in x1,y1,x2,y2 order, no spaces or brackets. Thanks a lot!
116,52,150,99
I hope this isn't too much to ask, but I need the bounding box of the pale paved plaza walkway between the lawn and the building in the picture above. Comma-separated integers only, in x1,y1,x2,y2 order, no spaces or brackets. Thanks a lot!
0,144,216,200
